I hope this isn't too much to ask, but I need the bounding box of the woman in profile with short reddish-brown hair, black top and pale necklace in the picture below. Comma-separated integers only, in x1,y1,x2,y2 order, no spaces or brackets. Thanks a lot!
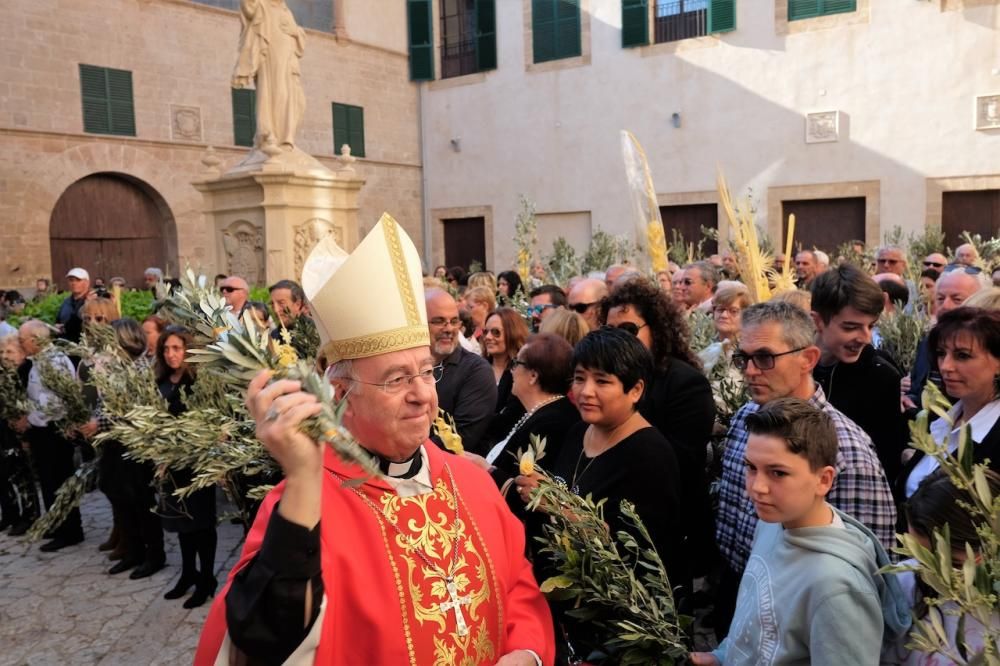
477,332,580,515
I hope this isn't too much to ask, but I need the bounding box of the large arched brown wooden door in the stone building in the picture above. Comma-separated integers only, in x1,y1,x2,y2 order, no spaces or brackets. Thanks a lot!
49,174,168,287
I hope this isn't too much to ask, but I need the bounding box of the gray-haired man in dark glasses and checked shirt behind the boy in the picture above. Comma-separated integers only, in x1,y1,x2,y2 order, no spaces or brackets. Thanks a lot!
716,301,896,633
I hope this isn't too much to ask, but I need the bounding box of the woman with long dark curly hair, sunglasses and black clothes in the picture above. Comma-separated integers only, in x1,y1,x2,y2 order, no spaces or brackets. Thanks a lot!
601,278,715,589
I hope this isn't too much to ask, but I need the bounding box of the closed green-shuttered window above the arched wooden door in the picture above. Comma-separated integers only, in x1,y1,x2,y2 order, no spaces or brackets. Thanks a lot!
80,64,135,136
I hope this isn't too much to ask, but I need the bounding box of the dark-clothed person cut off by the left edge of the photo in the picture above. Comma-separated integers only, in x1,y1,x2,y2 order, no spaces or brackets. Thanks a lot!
0,333,38,536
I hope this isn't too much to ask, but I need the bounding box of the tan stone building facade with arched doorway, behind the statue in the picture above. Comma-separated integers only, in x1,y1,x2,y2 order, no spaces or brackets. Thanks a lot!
0,0,424,288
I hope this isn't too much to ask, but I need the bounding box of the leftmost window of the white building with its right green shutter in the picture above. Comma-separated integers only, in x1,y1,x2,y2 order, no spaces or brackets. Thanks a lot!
440,0,497,79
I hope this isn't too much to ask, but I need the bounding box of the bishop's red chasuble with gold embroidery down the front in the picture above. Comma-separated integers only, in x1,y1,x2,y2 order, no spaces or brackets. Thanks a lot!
195,442,555,666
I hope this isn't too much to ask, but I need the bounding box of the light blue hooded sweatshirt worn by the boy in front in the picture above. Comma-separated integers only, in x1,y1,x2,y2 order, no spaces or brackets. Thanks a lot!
713,509,910,666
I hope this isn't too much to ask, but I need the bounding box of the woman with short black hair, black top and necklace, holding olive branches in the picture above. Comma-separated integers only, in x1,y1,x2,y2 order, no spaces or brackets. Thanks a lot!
516,328,686,657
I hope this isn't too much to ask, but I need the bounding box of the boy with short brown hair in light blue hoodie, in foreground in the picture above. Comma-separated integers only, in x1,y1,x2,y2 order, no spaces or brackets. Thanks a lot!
691,398,909,666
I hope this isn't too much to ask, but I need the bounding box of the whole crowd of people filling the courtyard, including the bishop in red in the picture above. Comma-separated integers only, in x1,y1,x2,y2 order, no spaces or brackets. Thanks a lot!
0,226,1000,664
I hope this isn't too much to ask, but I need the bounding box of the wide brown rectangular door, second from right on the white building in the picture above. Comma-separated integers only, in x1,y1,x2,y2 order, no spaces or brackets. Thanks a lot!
772,197,865,253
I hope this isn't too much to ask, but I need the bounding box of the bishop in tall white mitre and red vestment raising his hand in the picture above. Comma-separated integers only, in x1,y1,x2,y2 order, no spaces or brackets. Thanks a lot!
195,215,554,666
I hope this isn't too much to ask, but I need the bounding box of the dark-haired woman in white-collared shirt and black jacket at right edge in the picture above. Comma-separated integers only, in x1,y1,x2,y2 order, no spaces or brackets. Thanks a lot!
896,307,1000,499
